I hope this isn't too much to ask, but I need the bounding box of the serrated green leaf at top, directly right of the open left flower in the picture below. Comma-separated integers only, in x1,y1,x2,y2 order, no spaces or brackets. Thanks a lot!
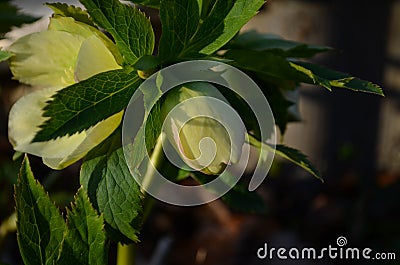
80,0,154,65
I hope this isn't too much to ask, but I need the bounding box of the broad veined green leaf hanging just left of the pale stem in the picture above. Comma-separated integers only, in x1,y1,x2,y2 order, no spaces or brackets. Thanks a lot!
80,129,142,241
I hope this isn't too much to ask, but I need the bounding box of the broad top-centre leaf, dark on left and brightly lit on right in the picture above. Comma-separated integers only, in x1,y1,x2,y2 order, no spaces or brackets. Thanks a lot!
159,0,264,60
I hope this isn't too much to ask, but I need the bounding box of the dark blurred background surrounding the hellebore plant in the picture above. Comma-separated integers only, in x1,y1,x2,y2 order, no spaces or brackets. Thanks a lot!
0,0,400,265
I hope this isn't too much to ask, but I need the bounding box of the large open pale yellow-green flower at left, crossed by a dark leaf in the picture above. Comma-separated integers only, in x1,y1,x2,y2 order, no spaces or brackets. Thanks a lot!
8,17,122,169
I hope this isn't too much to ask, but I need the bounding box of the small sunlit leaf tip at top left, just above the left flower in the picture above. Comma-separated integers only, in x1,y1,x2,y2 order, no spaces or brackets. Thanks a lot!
45,3,94,26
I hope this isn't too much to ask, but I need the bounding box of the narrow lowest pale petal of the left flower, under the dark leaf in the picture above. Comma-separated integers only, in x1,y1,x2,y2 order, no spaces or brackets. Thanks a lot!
43,111,123,169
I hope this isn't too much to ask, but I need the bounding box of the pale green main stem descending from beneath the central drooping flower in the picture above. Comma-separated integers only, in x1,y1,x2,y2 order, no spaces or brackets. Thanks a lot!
117,133,166,265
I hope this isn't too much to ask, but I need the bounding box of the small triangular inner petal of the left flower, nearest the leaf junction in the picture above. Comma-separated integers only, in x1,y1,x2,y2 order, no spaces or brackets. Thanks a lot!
75,35,121,82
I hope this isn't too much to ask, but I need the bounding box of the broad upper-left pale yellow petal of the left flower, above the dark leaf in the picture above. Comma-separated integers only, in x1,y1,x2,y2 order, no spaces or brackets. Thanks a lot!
8,31,84,88
